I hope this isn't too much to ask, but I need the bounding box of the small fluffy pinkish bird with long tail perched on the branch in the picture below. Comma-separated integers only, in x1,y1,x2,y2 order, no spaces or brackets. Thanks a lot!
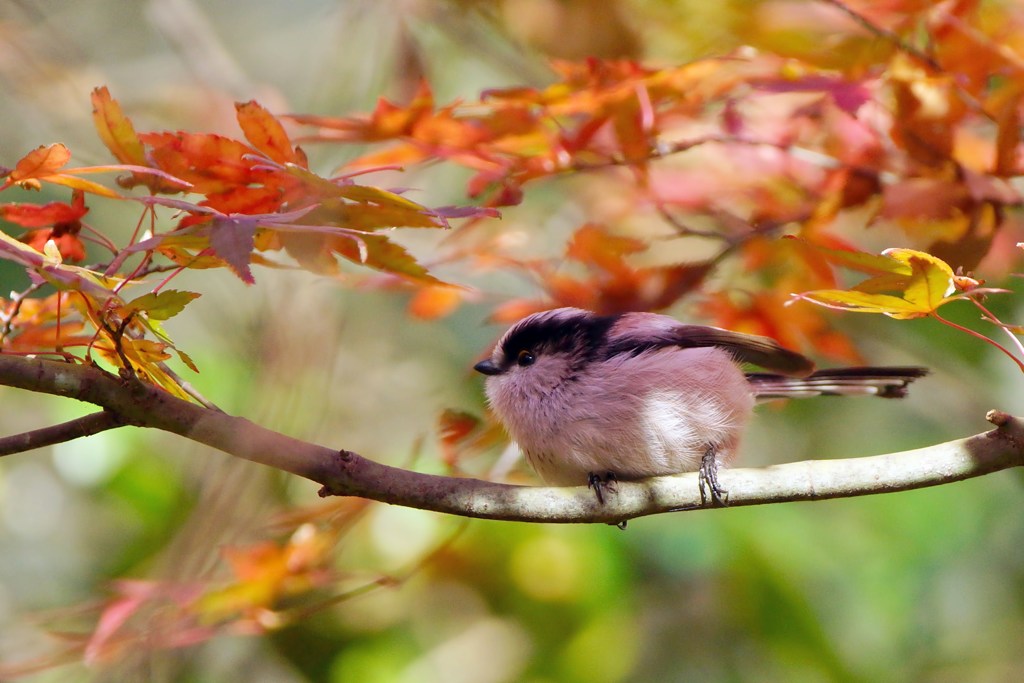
474,308,928,505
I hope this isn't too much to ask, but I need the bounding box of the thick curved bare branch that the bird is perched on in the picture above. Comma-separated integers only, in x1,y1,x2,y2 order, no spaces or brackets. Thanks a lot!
0,355,1024,523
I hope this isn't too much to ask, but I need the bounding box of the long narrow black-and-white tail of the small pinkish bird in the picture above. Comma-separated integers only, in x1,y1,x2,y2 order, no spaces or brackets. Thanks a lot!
746,368,928,399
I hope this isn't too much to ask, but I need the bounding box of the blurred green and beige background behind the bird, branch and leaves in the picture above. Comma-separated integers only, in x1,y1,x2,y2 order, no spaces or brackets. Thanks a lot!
0,0,1024,683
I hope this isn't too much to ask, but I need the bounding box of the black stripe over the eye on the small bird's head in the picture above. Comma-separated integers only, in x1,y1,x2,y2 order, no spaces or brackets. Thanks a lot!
500,309,620,368
